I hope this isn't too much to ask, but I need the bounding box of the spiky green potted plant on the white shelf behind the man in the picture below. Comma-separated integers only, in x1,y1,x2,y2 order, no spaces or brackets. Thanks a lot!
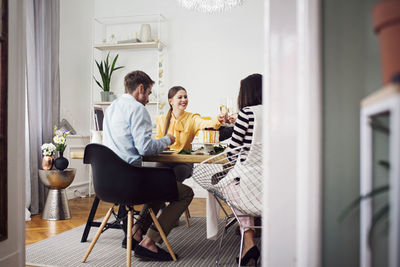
93,53,123,101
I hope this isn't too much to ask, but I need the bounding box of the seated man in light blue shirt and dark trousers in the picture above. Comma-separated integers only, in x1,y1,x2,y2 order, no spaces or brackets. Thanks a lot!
103,71,194,261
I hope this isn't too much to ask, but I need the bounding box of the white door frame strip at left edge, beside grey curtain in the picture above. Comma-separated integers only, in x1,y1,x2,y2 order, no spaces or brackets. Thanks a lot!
0,0,25,266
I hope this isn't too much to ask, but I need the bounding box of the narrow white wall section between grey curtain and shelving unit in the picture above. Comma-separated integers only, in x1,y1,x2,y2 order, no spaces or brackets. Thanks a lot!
60,0,94,134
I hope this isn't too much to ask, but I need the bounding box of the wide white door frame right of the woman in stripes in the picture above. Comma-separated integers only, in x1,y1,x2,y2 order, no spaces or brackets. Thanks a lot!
263,0,322,267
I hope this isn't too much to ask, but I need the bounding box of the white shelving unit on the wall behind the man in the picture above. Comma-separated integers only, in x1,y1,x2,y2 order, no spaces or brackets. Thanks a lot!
91,14,167,134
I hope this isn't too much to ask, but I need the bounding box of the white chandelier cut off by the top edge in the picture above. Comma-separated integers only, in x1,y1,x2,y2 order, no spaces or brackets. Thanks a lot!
178,0,243,13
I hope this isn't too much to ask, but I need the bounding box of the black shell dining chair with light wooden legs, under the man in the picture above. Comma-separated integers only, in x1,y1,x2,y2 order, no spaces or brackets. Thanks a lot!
82,144,178,266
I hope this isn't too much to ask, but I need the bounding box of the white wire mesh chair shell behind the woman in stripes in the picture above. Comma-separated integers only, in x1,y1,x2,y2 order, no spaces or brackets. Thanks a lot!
192,143,263,216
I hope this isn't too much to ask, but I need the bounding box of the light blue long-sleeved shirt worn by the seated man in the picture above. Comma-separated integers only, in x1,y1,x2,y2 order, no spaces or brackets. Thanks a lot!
103,94,171,165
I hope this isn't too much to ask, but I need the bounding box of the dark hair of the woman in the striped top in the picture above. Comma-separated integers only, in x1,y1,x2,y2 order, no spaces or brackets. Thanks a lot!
238,73,262,109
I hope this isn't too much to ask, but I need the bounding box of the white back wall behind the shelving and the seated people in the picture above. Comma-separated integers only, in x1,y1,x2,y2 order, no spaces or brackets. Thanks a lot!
60,0,264,134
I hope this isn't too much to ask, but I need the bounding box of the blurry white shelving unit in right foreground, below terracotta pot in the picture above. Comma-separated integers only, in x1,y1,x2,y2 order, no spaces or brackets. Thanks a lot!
360,84,400,267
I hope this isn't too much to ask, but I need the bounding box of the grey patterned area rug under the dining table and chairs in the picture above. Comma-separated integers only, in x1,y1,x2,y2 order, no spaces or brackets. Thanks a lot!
26,217,250,267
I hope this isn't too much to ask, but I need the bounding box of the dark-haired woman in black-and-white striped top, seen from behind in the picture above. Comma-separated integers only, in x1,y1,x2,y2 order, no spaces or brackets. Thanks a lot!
228,74,263,266
